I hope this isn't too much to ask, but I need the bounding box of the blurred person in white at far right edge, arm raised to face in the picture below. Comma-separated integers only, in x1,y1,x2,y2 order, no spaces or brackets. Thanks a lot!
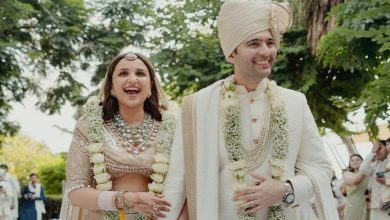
360,140,390,220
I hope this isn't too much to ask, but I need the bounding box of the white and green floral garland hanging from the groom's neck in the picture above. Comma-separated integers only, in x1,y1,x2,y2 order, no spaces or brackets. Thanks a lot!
221,76,288,220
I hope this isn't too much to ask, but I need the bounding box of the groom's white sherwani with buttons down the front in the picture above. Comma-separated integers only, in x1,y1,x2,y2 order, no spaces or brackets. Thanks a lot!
164,80,338,220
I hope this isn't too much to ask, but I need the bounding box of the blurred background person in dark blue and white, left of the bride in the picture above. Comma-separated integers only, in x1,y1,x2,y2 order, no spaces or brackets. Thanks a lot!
20,173,46,220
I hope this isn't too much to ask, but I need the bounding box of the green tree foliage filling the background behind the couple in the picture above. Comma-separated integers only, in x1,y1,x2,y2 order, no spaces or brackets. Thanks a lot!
0,0,390,142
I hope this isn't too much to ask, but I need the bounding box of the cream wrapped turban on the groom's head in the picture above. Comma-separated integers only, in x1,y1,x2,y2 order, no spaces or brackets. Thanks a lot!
217,0,292,59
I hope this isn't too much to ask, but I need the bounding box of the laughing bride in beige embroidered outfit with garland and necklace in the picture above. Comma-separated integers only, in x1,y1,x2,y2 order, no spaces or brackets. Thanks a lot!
60,53,180,220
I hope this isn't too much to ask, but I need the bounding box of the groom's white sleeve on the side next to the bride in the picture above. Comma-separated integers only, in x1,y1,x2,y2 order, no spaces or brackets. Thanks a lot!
164,114,186,220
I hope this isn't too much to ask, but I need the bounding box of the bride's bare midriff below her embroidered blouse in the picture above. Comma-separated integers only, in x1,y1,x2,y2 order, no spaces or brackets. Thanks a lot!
112,173,149,192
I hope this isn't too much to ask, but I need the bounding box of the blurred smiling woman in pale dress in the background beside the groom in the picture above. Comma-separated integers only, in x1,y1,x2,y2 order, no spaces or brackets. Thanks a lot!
343,154,369,220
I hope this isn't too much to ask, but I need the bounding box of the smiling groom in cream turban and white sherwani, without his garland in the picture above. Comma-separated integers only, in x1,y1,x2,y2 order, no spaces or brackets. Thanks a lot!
164,0,338,220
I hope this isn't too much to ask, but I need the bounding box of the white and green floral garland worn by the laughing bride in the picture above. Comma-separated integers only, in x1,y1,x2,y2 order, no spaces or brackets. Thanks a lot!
85,96,177,194
